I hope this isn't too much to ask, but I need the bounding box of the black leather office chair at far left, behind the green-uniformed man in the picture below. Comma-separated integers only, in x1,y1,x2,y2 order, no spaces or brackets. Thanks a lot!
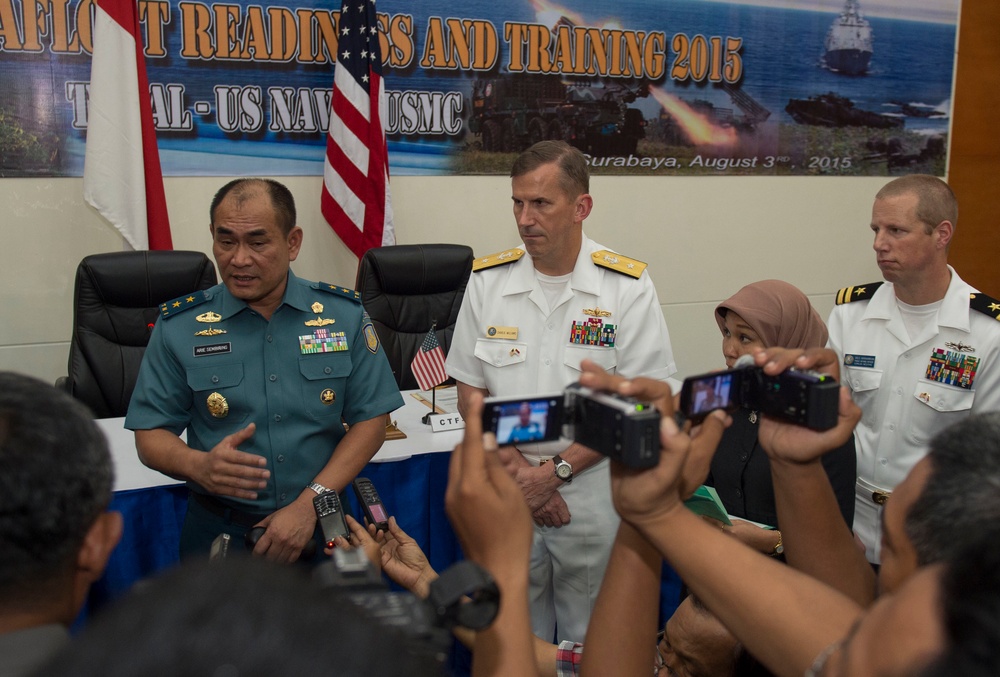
56,251,216,418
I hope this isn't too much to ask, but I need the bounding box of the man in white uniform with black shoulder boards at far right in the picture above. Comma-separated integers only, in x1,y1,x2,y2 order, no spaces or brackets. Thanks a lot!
828,175,1000,564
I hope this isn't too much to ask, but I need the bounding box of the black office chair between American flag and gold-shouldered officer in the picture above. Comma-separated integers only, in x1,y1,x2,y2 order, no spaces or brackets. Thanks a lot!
356,244,473,390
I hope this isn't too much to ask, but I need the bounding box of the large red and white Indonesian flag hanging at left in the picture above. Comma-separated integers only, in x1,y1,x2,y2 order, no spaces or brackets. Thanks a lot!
83,0,174,250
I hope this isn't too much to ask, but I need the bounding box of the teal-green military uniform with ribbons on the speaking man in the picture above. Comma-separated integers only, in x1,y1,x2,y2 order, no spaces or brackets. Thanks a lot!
125,271,403,552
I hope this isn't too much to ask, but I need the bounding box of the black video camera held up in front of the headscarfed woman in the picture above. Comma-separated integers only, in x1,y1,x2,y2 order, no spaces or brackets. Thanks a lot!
680,358,840,430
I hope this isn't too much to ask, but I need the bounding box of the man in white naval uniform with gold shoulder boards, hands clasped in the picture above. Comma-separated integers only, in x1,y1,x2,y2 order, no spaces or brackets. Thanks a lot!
447,141,676,642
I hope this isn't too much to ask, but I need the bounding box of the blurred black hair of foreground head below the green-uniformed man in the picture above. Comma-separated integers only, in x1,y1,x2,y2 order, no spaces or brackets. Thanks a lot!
39,555,442,677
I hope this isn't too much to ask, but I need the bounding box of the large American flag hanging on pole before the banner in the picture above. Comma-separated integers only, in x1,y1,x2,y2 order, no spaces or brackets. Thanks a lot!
320,0,396,258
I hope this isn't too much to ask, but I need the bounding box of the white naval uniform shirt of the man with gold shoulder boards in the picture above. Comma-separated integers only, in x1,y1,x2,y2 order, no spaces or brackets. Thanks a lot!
446,236,677,461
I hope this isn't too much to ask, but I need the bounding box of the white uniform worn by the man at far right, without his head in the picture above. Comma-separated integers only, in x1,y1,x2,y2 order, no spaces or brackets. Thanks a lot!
828,266,1000,562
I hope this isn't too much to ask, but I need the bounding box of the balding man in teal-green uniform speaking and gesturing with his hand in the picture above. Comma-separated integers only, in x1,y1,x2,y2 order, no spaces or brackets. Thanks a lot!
125,179,403,561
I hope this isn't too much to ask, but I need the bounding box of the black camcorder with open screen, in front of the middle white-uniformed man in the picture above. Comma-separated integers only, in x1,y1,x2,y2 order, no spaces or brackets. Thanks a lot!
483,383,660,468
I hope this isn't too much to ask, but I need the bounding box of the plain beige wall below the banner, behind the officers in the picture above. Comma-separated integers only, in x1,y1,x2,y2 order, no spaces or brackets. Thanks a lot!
0,176,884,381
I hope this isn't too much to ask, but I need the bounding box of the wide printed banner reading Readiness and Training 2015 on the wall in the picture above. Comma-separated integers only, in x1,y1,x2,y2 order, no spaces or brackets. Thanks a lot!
0,0,959,177
